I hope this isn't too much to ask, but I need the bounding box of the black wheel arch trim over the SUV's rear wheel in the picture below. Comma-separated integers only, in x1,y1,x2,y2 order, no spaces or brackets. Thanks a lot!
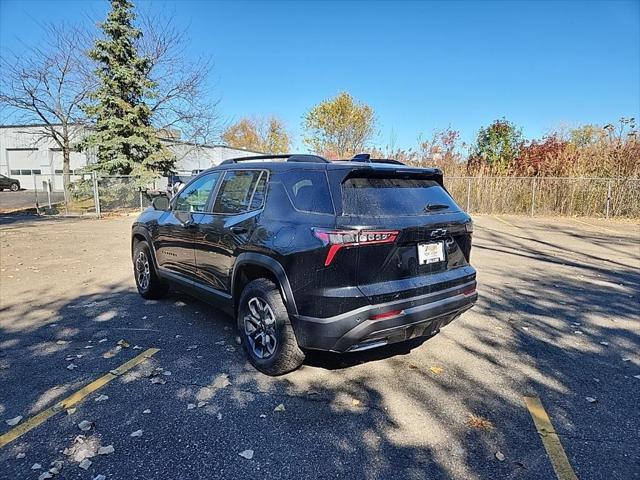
231,252,298,315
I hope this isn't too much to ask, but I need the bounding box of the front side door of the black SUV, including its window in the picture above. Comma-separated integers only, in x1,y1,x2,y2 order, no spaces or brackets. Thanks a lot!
154,172,220,277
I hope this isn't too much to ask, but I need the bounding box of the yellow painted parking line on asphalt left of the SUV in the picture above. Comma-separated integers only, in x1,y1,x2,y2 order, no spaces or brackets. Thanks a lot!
0,348,160,448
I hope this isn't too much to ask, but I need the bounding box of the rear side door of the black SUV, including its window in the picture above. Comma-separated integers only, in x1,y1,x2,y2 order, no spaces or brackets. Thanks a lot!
195,170,268,293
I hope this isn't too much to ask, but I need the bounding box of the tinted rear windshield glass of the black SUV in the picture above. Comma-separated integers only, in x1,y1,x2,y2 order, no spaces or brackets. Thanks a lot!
342,178,458,217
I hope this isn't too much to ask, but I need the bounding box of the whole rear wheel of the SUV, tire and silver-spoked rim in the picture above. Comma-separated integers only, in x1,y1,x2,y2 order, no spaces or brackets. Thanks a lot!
238,278,304,375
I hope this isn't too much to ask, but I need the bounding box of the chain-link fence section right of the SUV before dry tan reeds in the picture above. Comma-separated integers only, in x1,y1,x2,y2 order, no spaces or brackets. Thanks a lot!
445,177,640,218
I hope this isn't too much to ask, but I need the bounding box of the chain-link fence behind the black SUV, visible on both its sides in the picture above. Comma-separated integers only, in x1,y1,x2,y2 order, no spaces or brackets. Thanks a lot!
34,173,640,218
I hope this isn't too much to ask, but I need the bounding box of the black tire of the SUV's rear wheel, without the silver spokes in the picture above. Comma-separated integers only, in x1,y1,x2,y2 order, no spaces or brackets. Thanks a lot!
237,278,304,376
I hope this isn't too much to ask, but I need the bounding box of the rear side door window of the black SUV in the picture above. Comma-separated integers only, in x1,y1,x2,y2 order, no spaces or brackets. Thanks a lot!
213,170,267,214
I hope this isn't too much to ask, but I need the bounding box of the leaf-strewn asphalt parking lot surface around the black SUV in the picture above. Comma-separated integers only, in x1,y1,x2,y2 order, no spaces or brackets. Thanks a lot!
0,216,640,479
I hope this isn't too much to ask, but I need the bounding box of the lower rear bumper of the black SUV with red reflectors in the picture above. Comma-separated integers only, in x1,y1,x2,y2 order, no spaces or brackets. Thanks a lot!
291,280,478,352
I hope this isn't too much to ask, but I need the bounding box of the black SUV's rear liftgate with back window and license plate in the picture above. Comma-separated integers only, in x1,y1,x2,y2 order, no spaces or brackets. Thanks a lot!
338,169,472,303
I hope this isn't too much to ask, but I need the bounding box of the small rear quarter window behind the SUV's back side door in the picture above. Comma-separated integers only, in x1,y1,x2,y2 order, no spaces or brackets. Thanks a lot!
283,170,333,214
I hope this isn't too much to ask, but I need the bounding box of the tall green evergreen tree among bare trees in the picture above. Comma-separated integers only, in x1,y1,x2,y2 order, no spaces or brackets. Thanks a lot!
83,0,175,176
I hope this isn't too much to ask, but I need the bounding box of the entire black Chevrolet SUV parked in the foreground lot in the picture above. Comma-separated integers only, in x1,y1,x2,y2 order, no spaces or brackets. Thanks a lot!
131,155,477,375
